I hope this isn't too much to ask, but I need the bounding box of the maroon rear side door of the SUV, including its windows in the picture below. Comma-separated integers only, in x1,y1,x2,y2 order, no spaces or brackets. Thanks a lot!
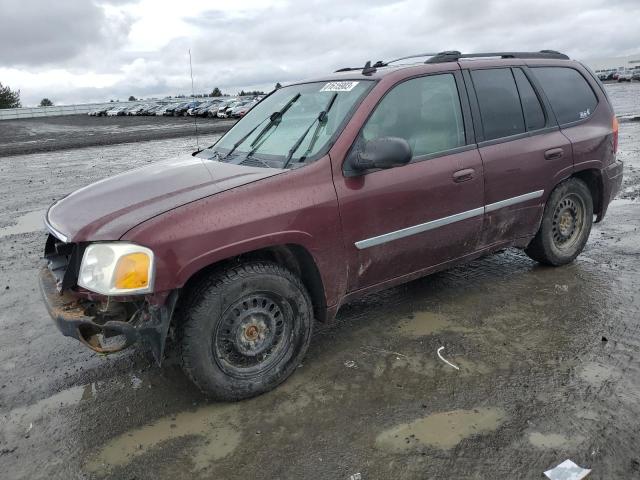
464,67,572,247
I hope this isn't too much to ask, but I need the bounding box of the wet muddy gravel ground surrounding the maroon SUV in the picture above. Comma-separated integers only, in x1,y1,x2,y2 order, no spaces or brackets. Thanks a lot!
0,86,640,479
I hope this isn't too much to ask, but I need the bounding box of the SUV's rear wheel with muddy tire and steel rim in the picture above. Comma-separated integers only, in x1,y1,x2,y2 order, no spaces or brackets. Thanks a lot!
525,178,593,266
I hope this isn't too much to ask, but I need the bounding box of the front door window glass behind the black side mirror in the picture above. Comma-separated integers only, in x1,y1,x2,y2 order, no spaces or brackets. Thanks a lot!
362,74,465,157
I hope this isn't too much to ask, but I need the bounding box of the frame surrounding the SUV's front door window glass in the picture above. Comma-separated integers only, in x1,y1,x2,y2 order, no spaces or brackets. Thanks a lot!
342,70,477,177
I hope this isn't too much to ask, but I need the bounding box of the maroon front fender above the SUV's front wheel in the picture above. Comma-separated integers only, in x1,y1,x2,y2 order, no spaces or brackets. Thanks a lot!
122,156,347,306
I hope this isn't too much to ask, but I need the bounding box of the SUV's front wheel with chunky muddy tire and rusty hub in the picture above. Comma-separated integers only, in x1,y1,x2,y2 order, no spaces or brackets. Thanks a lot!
180,262,313,400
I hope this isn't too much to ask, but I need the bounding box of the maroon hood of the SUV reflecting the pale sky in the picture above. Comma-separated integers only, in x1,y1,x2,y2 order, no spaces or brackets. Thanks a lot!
46,155,285,242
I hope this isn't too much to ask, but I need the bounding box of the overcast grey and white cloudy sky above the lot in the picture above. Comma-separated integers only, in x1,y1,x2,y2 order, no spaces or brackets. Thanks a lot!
0,0,640,105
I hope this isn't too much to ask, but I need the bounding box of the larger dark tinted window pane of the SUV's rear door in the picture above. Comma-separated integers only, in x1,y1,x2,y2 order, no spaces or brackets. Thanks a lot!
471,68,525,140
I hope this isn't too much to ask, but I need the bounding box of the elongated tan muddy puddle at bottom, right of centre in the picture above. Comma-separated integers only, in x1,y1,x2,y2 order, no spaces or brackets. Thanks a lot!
376,408,506,453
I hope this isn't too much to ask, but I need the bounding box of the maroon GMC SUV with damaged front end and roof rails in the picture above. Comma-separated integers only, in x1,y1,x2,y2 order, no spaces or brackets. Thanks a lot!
41,51,622,399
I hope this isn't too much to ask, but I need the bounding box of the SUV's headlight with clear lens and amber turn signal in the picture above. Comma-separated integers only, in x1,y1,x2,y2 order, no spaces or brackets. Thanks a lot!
78,242,154,296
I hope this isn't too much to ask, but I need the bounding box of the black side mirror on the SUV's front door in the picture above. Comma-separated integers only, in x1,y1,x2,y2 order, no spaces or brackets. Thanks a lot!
350,137,412,172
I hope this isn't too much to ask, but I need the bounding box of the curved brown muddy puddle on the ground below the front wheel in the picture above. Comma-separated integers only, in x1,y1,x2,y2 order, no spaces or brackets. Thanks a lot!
85,404,241,472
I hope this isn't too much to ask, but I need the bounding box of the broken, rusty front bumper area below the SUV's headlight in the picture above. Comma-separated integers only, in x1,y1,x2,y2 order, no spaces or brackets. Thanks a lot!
40,267,178,364
